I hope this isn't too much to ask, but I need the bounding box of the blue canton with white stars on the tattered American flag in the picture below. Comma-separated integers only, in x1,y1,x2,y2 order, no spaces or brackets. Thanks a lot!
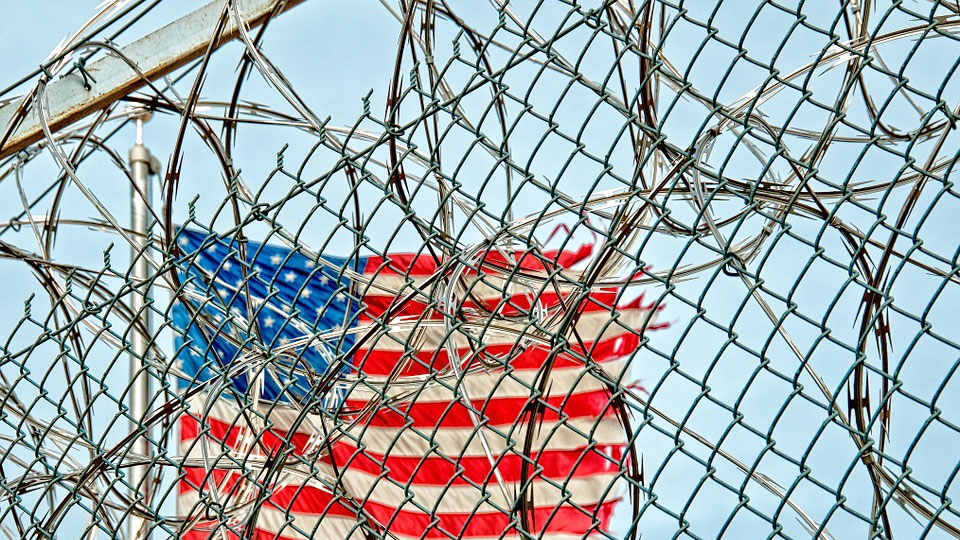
172,229,366,401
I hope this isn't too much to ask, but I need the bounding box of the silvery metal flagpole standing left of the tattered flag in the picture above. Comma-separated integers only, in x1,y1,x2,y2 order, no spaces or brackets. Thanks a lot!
127,112,159,540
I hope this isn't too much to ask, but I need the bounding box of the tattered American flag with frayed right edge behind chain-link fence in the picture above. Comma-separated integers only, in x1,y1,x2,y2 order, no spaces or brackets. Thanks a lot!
172,228,660,540
